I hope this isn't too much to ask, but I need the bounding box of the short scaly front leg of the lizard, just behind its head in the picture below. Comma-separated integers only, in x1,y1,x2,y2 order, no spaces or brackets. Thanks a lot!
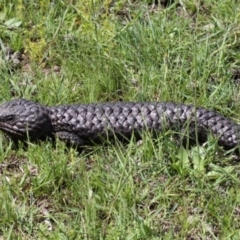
55,131,84,147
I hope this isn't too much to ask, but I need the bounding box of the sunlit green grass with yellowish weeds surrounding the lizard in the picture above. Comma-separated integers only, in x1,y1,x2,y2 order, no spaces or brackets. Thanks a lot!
0,0,240,240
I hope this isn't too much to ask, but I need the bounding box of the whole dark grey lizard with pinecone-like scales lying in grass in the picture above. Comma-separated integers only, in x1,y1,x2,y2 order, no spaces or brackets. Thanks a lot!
0,99,240,148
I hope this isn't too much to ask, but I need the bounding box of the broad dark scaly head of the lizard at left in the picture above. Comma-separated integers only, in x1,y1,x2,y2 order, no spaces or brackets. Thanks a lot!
0,99,51,140
